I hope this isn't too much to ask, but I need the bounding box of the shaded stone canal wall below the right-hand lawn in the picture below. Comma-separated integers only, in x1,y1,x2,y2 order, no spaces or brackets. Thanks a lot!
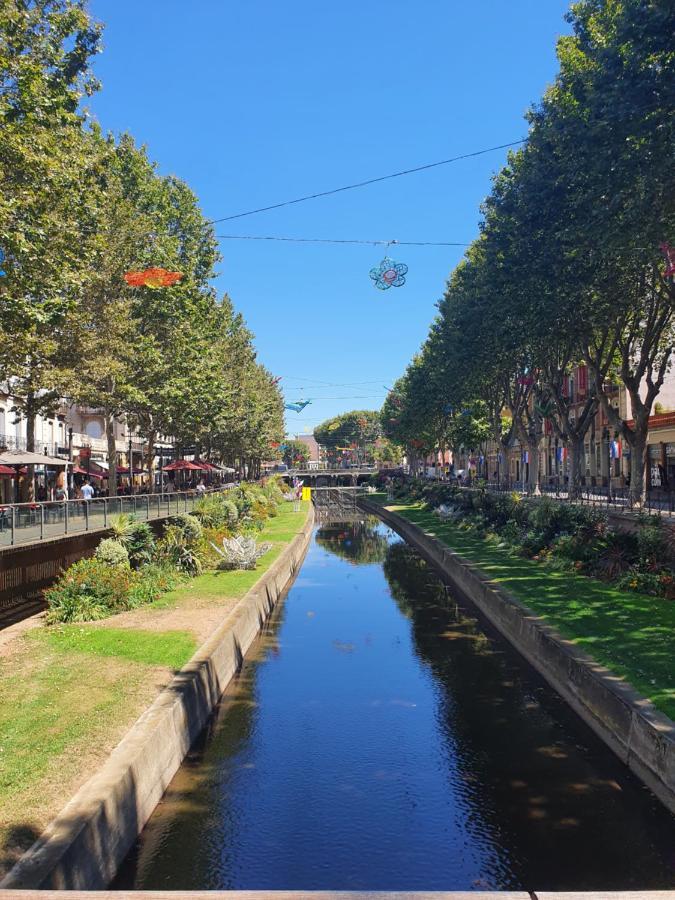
368,500,675,812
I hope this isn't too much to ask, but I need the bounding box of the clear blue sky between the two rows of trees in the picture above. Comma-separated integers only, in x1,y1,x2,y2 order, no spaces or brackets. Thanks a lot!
84,0,568,432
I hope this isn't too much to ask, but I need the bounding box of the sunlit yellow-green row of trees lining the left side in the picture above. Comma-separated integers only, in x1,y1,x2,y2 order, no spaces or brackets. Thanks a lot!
0,0,283,492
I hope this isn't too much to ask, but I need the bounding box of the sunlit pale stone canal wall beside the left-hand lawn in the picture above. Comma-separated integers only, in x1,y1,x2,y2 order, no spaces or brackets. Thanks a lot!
0,507,314,891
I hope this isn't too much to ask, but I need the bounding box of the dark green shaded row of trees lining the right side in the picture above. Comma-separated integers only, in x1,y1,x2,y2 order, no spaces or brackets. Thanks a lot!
383,0,675,502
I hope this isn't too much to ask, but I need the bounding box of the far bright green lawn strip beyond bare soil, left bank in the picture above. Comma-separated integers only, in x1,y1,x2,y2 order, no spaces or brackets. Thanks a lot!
152,502,309,610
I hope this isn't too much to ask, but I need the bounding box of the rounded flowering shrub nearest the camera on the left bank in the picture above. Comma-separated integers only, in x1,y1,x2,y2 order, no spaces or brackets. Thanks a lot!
45,557,137,622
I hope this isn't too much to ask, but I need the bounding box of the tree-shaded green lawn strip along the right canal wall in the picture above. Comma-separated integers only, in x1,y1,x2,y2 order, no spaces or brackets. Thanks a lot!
390,498,675,719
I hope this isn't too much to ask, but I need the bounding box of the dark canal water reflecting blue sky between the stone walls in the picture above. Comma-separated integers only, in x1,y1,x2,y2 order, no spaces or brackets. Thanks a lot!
113,520,675,891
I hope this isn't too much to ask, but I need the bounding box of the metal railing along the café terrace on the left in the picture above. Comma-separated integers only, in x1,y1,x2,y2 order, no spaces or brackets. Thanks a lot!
0,484,237,549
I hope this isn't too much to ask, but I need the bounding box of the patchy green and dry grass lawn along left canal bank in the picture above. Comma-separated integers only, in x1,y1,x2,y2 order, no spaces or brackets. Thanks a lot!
0,503,309,872
